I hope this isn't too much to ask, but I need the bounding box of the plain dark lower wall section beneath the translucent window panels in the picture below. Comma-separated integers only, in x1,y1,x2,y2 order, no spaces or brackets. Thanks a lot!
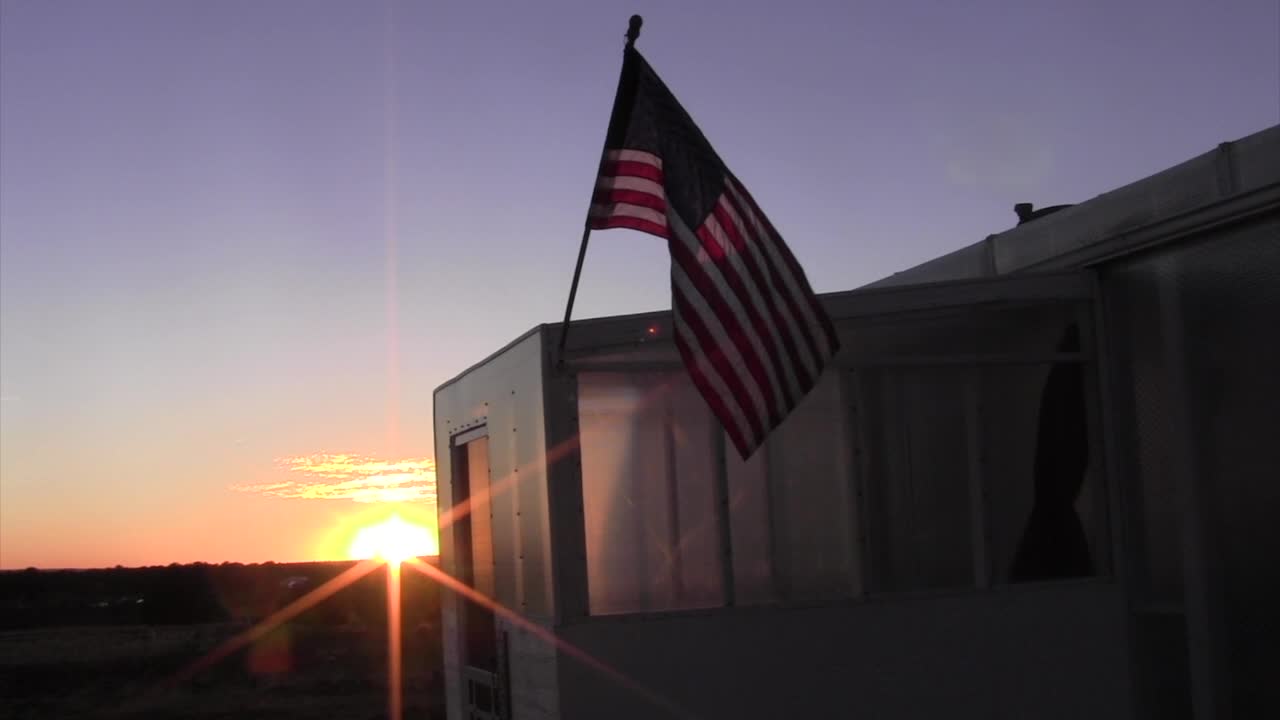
561,583,1130,720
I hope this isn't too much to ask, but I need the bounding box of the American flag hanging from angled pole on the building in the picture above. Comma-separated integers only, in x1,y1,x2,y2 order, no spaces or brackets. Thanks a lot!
590,47,840,459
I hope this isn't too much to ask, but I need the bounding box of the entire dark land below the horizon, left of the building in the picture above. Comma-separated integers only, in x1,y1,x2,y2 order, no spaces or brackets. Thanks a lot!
0,559,443,720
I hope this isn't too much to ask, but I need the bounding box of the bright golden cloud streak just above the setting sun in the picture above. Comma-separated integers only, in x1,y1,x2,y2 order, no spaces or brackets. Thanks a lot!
232,452,435,502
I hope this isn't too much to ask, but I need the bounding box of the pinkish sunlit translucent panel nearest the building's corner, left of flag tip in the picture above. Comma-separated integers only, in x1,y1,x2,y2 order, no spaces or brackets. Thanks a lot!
579,373,723,615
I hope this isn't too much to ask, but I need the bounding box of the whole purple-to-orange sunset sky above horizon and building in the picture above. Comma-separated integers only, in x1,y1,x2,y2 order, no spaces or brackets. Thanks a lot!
0,0,1280,568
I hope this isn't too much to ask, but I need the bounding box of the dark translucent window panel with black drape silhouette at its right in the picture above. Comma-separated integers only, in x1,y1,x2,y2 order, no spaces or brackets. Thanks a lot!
847,302,1110,592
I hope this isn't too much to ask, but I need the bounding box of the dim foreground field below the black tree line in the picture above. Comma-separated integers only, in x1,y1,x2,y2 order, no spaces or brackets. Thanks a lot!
0,624,443,720
